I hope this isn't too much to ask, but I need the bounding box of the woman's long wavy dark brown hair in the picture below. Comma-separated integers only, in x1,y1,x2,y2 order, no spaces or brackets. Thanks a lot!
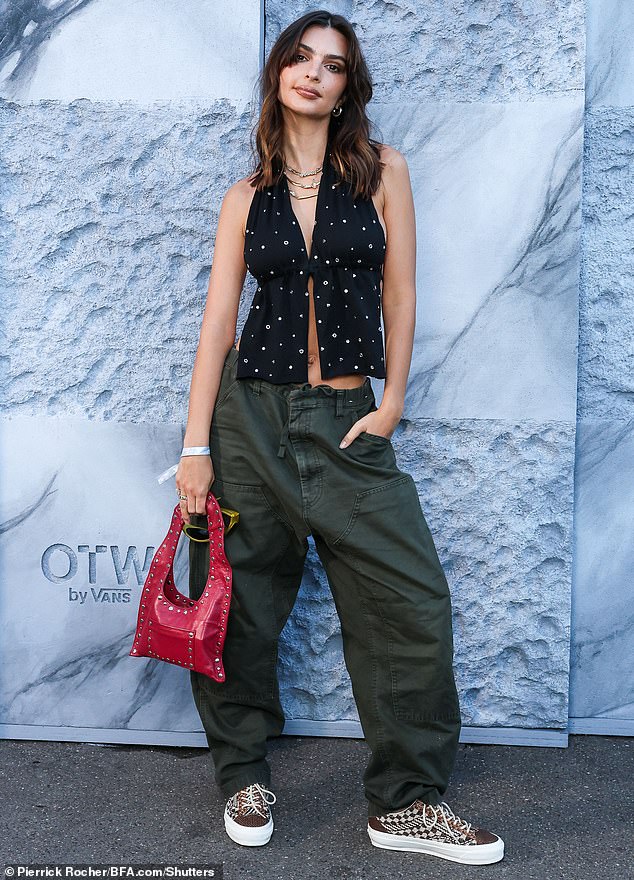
249,9,384,198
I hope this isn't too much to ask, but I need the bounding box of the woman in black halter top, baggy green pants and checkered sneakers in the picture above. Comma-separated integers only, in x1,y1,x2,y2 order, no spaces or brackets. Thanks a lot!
176,11,503,864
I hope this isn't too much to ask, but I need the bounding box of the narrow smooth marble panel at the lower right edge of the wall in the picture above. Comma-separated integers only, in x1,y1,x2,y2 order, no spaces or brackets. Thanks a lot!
570,419,634,720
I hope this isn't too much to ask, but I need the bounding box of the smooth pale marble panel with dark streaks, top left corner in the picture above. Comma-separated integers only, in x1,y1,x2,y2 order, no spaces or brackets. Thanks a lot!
0,0,260,109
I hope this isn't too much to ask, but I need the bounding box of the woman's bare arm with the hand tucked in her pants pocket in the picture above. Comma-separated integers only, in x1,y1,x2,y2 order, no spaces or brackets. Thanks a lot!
345,147,416,445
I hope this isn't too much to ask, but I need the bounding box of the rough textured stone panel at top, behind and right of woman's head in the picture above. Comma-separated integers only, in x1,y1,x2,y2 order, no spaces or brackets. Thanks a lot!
265,0,584,103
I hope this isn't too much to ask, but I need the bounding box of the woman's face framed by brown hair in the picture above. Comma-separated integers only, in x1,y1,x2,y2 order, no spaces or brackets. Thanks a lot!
277,25,348,117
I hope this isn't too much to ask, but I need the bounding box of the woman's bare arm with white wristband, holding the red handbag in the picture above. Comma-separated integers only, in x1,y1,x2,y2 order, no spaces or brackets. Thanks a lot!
176,180,253,522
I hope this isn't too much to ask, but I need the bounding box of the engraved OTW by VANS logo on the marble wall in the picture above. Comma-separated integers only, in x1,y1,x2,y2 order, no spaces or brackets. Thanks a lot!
40,544,156,605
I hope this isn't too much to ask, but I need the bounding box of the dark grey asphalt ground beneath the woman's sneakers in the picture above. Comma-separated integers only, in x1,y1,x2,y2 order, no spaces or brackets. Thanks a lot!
0,735,634,880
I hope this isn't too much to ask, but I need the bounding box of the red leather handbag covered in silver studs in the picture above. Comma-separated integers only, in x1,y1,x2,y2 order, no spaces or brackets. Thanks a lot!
130,492,237,682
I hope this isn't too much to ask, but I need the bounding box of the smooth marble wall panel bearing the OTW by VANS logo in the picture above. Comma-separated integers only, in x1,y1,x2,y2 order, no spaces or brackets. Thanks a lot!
0,417,207,741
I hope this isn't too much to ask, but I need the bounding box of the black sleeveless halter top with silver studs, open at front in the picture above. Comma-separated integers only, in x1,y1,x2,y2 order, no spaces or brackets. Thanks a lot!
236,143,386,384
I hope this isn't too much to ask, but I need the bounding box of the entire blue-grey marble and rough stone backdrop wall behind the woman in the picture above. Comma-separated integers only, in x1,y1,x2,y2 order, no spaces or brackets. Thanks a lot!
0,0,634,745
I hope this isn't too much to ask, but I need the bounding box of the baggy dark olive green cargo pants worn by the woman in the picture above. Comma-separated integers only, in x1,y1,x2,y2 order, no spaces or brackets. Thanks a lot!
189,346,461,815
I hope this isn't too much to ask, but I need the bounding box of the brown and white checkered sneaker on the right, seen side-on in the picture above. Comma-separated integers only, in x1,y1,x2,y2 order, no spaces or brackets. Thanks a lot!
368,800,504,865
